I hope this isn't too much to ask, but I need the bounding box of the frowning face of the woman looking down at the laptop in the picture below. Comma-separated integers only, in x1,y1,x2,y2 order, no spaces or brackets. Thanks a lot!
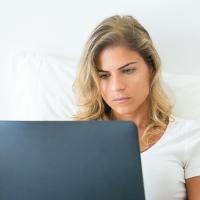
97,46,150,118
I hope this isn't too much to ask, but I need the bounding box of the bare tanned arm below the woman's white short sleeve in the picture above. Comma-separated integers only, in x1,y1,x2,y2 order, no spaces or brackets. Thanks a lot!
186,176,200,200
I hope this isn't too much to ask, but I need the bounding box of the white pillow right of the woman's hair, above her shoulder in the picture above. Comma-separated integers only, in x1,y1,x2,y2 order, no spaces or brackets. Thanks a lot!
163,73,200,120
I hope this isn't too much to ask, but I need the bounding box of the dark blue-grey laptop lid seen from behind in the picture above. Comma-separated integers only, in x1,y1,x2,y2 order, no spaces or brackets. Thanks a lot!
0,121,145,200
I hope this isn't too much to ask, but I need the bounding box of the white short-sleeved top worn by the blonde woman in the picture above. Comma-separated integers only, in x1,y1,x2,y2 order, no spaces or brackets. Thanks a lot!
141,118,200,200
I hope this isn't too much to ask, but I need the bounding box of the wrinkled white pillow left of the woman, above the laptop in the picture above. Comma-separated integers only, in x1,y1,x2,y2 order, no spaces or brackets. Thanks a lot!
8,52,77,120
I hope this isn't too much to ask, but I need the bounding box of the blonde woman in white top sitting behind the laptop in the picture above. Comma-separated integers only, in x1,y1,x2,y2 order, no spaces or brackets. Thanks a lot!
74,16,200,200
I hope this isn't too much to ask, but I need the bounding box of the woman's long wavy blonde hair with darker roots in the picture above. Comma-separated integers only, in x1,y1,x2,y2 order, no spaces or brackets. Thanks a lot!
73,15,173,144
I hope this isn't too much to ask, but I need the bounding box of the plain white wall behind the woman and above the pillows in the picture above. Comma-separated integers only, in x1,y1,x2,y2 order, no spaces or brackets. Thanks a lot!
0,0,200,74
